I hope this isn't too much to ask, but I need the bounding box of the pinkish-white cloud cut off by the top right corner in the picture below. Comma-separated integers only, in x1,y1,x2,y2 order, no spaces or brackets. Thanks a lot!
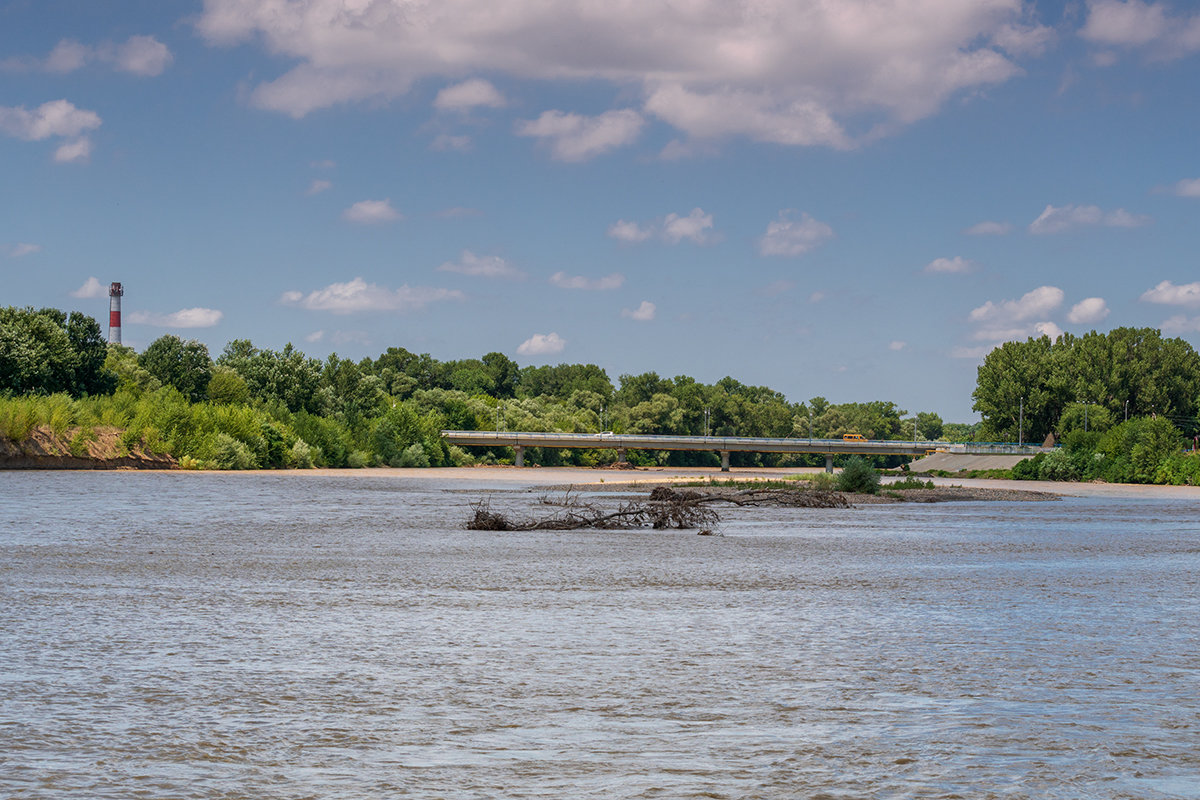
1079,0,1200,60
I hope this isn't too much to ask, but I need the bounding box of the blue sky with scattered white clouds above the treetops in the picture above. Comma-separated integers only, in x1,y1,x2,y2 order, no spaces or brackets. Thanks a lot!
0,0,1200,421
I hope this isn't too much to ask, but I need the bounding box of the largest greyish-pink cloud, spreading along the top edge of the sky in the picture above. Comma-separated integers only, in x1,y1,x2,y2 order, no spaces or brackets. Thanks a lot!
197,0,1032,148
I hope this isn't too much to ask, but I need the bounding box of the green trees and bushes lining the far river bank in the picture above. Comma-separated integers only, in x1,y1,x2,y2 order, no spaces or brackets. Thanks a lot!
0,307,1200,480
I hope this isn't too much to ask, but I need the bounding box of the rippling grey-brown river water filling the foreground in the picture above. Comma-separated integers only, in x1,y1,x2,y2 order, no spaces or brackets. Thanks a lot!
0,473,1200,799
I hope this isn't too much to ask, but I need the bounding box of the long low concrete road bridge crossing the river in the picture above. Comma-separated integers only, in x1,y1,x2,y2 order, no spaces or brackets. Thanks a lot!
442,431,1046,473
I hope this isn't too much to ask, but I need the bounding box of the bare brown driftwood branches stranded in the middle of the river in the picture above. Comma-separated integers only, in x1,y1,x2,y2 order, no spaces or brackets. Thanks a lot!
467,486,850,534
